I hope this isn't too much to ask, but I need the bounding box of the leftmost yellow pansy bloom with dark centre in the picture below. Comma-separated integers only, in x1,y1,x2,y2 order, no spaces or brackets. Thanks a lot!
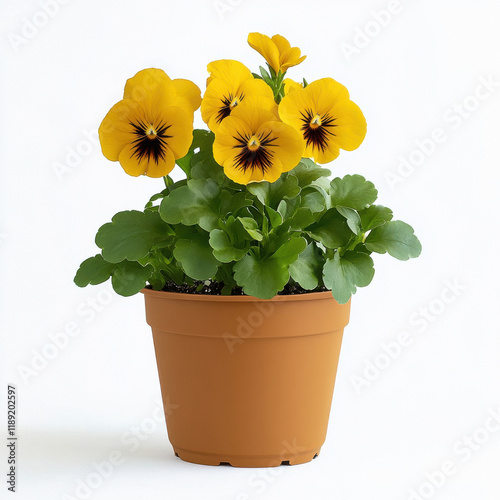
99,69,201,177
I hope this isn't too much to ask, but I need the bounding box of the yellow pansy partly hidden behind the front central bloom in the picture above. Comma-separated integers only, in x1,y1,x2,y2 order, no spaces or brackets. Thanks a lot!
201,60,278,132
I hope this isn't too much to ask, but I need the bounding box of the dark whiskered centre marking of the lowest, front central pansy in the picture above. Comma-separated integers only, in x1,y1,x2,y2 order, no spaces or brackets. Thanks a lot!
234,132,278,173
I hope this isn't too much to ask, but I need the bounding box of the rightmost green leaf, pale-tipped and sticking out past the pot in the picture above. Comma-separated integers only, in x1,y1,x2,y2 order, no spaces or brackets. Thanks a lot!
365,220,422,260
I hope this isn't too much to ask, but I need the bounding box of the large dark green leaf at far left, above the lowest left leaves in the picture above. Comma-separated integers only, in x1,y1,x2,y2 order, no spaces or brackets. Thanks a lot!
95,210,173,263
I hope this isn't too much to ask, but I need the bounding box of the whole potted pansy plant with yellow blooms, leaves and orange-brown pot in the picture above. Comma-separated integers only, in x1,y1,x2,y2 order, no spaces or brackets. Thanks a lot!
75,33,421,467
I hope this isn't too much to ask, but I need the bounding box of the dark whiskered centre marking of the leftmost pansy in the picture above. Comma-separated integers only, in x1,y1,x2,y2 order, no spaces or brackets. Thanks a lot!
130,120,172,165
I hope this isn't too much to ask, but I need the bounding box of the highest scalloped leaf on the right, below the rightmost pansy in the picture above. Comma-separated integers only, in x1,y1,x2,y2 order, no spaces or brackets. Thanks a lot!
330,174,378,210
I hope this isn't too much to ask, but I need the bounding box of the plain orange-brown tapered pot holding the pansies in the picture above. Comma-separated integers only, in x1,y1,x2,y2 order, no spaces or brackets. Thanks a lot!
143,289,350,467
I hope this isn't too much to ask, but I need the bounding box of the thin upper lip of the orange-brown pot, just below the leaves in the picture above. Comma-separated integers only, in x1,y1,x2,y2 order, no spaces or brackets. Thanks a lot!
141,288,344,302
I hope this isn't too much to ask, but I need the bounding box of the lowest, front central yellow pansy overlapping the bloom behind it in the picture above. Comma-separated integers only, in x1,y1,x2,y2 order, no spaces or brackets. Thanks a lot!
213,105,304,184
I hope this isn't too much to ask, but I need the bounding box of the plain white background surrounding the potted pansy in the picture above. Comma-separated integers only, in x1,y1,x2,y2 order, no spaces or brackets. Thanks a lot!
0,0,500,500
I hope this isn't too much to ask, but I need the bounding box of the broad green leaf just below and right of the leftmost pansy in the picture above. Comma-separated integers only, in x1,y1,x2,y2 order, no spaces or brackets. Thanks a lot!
160,179,220,231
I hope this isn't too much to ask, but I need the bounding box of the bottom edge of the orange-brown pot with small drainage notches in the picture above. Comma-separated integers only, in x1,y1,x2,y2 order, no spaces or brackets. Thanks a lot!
174,447,320,468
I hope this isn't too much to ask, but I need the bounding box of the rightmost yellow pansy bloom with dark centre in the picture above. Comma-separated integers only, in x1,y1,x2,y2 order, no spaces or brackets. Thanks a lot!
279,78,366,163
